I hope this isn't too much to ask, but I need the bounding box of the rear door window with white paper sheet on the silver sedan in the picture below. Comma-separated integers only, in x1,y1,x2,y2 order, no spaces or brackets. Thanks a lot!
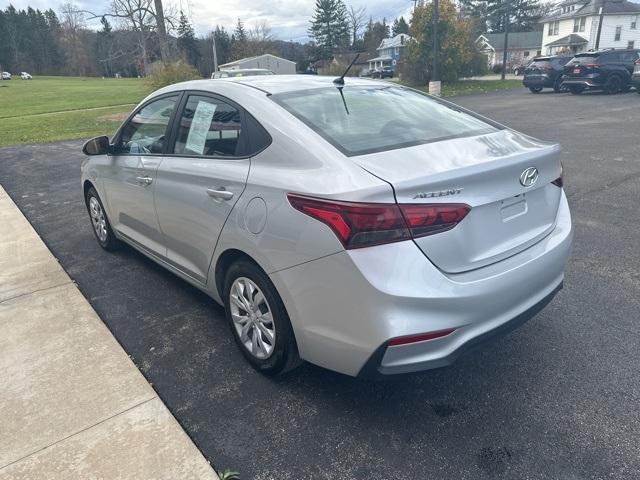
173,95,245,157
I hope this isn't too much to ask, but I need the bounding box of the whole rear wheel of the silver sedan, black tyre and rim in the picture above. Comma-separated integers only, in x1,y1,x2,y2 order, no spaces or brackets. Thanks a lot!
223,260,302,376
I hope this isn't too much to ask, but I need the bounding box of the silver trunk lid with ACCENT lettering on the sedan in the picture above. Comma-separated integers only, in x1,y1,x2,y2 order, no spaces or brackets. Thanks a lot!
352,130,561,273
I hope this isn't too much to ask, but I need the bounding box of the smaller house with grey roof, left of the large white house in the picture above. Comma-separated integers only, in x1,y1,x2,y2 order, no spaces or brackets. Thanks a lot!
476,31,542,70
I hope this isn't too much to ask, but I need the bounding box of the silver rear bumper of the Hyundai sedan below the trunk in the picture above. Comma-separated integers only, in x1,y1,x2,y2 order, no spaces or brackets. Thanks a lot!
271,194,572,376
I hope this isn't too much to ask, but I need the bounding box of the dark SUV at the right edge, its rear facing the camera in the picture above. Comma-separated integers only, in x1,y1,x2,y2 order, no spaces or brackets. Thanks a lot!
563,49,640,94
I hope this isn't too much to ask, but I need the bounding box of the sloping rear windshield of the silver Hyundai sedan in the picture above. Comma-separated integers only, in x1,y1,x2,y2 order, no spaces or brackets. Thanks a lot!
271,86,499,156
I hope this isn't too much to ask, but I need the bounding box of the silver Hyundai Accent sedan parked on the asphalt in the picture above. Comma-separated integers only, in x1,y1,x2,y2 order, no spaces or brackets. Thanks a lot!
82,75,572,377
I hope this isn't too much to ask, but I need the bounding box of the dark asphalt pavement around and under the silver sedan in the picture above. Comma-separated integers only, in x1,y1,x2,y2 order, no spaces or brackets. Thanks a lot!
0,89,640,480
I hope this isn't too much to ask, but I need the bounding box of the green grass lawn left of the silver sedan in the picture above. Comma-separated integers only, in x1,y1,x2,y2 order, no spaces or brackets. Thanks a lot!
0,77,148,146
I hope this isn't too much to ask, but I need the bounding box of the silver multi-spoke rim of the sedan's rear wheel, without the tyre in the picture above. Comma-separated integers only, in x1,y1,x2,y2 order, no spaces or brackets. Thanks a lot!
229,277,276,360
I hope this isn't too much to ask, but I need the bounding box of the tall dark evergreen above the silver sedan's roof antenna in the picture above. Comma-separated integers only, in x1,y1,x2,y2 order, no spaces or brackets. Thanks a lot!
308,0,349,58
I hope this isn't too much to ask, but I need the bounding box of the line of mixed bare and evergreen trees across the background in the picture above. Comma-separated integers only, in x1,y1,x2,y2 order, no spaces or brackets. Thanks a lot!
0,0,544,77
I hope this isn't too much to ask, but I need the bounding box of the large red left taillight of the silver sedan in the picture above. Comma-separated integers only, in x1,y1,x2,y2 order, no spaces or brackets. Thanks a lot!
287,194,471,249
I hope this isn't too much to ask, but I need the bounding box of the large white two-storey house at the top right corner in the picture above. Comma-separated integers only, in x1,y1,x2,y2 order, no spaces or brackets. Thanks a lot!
540,0,640,55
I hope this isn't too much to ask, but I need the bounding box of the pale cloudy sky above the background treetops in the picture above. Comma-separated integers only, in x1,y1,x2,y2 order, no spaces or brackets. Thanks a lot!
0,0,413,42
